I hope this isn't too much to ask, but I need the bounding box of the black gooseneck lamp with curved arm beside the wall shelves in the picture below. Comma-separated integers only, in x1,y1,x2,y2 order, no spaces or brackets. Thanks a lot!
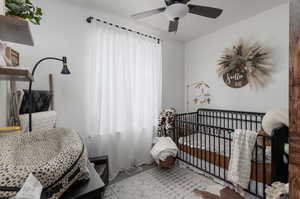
28,57,71,132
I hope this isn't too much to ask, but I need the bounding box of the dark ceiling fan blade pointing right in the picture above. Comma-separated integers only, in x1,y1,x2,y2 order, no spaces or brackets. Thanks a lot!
188,4,223,18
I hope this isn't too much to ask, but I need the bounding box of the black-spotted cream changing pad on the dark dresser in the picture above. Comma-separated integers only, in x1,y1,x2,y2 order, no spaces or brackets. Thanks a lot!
0,129,88,199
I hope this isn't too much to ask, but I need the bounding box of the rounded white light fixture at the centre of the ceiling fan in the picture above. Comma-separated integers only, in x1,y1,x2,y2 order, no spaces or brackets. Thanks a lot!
165,3,189,21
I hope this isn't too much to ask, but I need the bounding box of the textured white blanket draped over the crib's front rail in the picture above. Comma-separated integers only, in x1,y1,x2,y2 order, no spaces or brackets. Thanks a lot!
228,129,257,189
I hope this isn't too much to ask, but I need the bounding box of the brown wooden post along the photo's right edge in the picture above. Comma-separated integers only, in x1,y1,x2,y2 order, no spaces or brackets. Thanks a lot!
289,0,300,199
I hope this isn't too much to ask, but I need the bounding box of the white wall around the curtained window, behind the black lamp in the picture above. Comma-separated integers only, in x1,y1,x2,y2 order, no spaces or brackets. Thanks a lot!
6,0,184,134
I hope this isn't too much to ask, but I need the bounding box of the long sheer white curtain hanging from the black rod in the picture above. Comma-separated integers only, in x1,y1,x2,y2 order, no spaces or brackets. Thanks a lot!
87,22,162,177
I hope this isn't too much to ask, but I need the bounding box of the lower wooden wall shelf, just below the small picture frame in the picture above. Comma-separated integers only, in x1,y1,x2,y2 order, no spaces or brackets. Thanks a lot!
0,67,33,81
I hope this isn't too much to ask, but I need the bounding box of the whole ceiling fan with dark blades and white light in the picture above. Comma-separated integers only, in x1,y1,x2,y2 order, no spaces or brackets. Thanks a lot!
132,0,223,32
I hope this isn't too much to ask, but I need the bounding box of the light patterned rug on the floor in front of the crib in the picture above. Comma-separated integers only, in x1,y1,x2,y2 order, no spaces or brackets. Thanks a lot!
104,167,224,199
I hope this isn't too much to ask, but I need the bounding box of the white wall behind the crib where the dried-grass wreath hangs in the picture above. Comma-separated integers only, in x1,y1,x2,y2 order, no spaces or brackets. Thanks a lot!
185,3,289,111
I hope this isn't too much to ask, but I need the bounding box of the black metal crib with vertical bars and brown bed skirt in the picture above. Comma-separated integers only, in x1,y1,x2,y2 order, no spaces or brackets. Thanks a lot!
172,109,288,198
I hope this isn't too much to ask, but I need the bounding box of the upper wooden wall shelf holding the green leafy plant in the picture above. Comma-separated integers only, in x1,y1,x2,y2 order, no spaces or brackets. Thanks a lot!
0,15,34,46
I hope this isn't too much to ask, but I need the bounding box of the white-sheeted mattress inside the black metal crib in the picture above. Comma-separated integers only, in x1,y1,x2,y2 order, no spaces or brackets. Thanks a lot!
178,132,272,163
